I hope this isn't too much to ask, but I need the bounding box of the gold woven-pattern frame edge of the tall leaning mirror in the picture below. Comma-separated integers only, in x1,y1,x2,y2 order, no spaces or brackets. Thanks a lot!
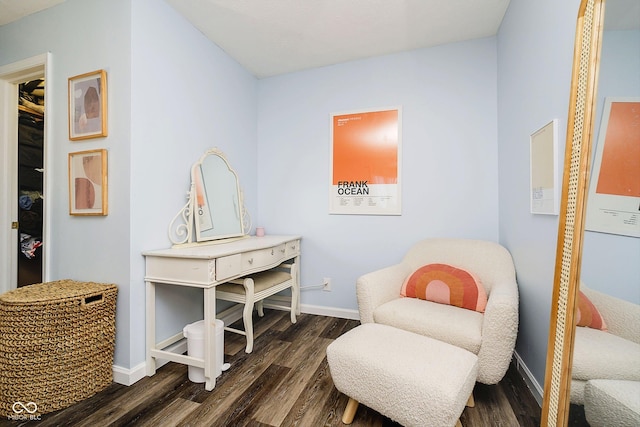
540,0,605,426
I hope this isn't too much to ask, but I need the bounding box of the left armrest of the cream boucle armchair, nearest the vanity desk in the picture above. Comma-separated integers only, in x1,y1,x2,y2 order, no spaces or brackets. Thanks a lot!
356,264,411,323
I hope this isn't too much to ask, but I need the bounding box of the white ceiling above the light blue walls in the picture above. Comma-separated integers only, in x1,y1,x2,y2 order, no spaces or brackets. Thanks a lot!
0,0,640,77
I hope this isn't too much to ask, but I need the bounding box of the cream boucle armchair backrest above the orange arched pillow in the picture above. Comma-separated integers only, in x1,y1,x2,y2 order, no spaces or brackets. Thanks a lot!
402,238,516,295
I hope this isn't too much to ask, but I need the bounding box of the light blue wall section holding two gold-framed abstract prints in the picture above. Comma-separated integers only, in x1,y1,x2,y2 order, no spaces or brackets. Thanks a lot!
0,0,133,366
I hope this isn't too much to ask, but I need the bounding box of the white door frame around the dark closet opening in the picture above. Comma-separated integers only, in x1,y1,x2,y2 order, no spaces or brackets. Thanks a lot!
0,53,53,293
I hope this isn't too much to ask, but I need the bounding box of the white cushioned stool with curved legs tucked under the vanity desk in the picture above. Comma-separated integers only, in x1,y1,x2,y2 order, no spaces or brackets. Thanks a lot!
216,262,300,353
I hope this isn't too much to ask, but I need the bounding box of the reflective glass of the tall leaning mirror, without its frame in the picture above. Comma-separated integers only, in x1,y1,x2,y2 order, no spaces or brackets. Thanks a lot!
569,0,640,427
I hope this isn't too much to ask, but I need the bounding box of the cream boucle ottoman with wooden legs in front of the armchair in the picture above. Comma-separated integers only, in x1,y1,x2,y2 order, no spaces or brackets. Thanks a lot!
327,323,478,427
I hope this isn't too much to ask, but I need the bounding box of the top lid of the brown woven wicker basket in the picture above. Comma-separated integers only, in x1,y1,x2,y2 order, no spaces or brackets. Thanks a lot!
0,279,116,304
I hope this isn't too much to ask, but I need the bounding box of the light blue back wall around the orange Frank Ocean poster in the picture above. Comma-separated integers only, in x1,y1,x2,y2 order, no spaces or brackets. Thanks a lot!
256,38,498,310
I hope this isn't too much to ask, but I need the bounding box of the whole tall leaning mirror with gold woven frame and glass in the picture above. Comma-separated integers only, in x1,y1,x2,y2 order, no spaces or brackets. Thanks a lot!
542,0,640,427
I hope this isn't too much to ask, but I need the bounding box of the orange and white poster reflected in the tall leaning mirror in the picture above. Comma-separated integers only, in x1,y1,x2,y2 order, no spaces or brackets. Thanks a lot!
586,98,640,237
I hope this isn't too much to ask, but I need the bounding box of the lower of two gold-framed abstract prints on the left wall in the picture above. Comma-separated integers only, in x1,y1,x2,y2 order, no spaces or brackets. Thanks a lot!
69,149,108,216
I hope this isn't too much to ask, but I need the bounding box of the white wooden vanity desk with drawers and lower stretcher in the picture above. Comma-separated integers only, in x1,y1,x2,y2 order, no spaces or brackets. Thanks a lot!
142,236,300,391
